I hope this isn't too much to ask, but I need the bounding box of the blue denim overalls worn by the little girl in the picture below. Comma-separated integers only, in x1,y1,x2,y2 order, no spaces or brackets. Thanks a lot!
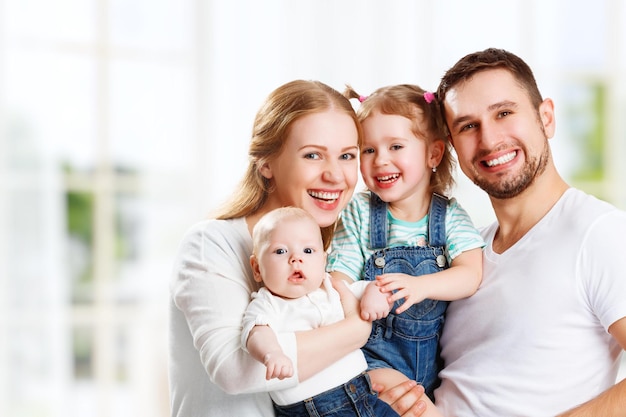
362,193,448,399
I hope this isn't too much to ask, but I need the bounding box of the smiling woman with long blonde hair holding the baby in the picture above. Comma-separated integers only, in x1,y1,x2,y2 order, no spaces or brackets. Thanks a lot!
170,81,424,417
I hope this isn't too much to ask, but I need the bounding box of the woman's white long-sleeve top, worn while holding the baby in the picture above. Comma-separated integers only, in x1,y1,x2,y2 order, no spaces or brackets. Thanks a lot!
169,218,298,417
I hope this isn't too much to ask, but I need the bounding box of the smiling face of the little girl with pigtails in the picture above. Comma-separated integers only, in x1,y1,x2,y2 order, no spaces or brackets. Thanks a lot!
361,112,443,207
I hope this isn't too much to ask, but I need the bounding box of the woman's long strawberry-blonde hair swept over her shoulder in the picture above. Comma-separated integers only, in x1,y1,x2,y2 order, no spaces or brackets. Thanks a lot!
215,80,361,247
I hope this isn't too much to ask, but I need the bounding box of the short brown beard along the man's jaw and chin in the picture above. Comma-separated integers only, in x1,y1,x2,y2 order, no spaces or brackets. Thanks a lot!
474,139,550,199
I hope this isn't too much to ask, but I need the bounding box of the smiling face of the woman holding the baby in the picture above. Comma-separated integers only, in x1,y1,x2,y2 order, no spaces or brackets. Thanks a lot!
260,110,358,227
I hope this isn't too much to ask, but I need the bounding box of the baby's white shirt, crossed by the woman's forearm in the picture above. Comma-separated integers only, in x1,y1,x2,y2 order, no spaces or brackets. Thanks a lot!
241,274,367,405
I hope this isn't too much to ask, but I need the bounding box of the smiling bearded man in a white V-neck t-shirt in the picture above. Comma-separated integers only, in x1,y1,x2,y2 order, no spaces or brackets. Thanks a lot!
435,49,626,417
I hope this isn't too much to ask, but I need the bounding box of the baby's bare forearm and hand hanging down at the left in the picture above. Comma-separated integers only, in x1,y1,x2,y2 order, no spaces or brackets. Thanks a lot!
246,326,293,380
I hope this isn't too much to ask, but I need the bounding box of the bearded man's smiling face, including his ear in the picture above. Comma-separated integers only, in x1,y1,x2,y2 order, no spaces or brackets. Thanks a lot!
444,69,554,199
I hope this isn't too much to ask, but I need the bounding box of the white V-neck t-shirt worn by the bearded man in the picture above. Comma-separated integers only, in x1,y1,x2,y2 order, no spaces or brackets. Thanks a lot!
435,189,626,417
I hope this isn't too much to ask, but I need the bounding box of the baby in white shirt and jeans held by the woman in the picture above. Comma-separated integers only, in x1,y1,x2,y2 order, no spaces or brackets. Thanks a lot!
242,207,398,417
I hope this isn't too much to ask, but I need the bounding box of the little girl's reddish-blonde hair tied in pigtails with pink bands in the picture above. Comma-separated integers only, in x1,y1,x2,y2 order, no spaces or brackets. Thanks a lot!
344,84,454,195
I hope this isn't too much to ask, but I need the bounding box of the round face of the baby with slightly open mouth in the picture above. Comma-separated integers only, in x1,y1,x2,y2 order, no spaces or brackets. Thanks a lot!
258,219,326,298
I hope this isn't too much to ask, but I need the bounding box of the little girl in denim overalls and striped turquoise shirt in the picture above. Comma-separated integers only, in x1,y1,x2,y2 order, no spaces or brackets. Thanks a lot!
327,85,484,398
